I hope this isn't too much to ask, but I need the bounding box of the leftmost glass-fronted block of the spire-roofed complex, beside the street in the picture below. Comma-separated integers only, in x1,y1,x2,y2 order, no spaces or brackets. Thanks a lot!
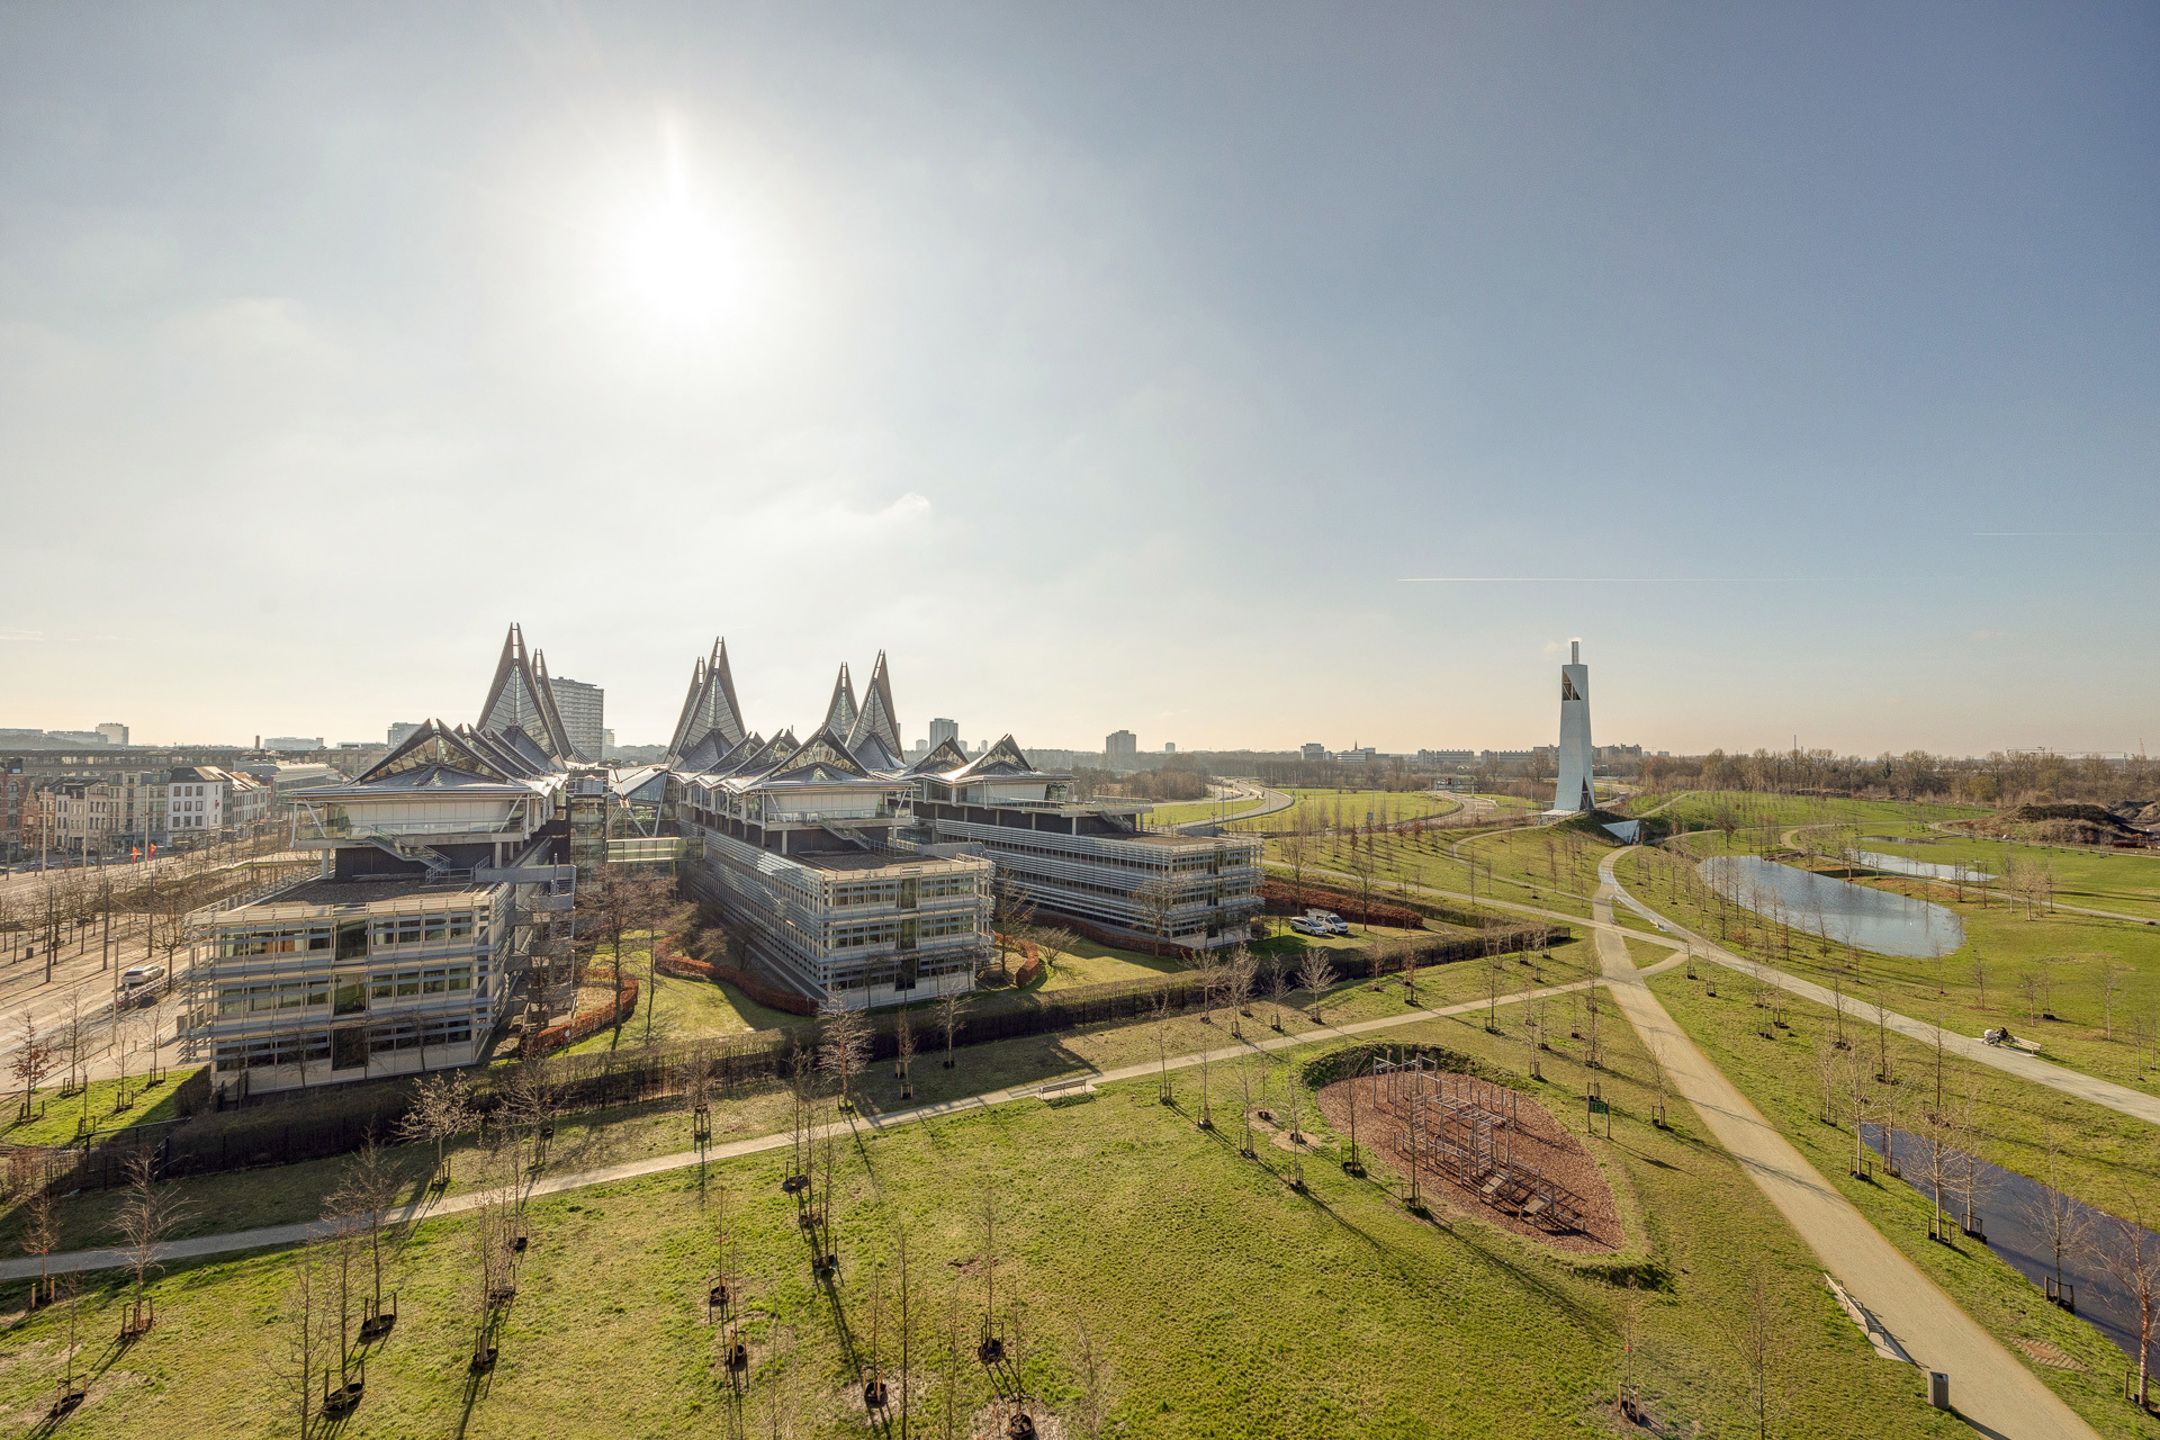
175,626,583,1095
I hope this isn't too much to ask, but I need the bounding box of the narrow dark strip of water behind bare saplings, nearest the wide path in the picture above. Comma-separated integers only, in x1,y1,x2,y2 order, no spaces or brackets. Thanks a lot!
1860,1125,2160,1360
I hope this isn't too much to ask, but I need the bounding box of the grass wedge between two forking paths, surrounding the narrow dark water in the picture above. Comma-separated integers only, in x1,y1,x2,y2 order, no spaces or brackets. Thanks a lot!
1650,972,2160,1440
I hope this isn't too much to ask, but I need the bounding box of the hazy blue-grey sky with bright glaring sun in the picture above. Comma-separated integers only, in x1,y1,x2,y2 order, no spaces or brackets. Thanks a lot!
0,0,2160,751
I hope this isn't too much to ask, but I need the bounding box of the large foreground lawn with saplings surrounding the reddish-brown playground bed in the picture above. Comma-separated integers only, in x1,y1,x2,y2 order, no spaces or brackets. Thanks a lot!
0,1001,1961,1440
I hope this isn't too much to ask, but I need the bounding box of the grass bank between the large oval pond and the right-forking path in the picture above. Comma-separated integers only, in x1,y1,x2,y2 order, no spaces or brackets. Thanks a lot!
1618,833,2160,1092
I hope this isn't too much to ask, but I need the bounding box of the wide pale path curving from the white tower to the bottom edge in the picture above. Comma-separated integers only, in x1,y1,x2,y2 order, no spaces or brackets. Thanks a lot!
1592,851,2093,1440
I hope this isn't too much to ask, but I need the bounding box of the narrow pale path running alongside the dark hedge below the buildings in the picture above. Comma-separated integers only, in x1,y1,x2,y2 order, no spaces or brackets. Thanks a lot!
0,954,1632,1280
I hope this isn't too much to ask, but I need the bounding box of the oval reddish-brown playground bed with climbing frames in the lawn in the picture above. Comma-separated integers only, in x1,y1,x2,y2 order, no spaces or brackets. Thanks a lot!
1318,1073,1626,1254
